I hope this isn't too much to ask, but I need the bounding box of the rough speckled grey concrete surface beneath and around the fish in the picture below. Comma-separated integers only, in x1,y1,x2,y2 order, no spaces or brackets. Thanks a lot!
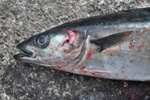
0,0,150,100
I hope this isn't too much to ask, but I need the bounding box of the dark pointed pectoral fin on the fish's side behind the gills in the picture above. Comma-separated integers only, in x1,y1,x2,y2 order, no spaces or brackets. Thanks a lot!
90,31,133,52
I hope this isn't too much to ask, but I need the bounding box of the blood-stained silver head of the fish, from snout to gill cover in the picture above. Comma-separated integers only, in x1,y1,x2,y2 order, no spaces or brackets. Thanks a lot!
14,30,85,66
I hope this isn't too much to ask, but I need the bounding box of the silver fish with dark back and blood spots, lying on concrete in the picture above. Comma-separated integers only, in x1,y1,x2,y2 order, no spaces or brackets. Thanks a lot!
14,8,150,81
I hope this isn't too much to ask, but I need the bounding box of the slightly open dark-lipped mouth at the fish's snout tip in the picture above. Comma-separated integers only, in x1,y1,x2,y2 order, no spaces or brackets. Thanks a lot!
14,43,33,60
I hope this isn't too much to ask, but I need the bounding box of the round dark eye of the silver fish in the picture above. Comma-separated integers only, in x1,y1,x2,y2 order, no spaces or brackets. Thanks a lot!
34,34,50,48
